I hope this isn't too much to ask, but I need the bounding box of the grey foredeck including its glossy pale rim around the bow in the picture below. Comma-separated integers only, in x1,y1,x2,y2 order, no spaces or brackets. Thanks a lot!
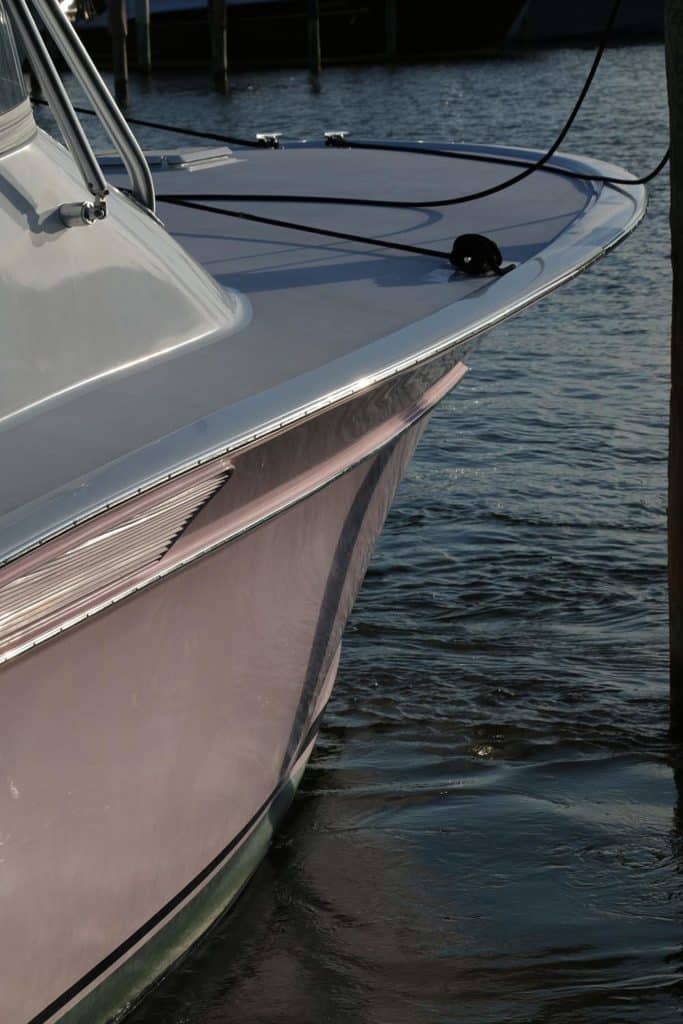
0,143,645,558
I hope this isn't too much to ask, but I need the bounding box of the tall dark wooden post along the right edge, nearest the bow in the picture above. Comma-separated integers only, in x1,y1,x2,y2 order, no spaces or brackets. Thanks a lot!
666,0,683,738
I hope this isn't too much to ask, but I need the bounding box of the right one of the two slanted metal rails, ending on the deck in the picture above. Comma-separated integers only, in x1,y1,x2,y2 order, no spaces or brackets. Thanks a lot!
30,0,156,213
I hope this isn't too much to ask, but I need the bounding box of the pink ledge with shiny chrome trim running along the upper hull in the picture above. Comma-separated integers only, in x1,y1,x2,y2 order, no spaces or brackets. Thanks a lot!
0,362,467,666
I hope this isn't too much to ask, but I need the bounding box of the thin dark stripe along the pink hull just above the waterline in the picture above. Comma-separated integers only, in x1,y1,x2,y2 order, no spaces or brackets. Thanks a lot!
27,708,325,1024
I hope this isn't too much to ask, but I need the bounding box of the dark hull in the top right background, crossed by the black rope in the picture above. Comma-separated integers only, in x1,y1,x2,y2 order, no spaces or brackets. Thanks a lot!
509,0,664,45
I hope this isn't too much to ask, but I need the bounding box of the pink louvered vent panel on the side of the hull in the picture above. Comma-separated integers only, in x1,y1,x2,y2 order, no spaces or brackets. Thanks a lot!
0,463,230,653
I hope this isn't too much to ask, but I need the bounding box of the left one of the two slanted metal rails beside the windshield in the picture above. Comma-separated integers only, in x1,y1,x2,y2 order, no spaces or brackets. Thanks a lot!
6,0,108,203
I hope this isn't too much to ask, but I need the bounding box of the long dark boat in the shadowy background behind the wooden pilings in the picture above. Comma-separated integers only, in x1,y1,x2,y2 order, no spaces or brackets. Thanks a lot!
75,0,523,69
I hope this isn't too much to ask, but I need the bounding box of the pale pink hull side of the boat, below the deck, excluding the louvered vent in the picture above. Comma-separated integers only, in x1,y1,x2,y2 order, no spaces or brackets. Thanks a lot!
0,352,471,1024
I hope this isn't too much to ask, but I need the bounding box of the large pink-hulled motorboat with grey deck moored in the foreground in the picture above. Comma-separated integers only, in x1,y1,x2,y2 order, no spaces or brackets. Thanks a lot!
0,0,645,1024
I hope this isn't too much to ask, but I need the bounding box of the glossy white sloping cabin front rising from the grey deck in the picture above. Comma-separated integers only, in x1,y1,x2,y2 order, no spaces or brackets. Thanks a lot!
0,130,250,436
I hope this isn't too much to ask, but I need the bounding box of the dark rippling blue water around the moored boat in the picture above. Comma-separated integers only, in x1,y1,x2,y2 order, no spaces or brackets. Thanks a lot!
62,39,671,1024
